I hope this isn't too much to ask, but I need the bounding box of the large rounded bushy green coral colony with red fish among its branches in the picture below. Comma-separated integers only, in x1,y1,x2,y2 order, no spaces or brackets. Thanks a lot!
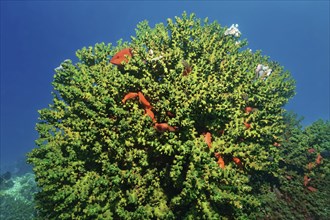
28,13,324,219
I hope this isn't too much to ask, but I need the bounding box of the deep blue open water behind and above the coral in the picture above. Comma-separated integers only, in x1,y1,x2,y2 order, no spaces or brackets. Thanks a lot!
0,1,330,173
